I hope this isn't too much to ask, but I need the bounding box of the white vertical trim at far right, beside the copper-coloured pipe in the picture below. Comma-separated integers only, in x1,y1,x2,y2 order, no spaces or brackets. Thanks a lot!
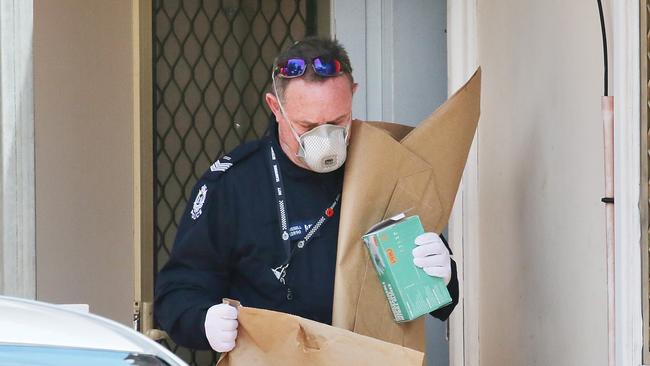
609,0,647,366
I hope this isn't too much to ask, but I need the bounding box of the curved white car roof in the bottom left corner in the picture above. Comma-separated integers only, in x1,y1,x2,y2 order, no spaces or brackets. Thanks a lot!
0,296,182,362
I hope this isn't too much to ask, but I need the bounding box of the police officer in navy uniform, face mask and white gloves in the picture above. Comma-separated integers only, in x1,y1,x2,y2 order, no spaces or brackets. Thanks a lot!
155,38,458,352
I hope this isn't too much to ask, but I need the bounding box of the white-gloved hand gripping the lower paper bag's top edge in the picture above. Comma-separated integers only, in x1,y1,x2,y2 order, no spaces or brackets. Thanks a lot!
204,304,239,352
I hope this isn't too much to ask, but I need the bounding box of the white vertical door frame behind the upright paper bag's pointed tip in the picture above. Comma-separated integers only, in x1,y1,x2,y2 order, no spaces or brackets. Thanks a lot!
447,0,481,366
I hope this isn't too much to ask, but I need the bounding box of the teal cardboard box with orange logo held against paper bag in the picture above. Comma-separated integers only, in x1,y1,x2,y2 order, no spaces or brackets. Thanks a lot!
363,213,451,322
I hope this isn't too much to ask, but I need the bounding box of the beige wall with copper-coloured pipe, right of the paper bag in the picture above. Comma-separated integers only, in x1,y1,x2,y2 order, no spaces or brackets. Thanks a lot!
478,0,611,366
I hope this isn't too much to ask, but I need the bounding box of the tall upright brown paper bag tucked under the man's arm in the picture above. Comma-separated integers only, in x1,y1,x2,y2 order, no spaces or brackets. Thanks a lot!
332,68,481,351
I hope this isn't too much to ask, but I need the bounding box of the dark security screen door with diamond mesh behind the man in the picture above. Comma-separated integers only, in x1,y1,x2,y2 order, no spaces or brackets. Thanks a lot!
152,0,322,365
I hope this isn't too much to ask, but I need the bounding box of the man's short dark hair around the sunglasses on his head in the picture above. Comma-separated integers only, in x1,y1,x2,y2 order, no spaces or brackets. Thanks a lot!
273,36,354,98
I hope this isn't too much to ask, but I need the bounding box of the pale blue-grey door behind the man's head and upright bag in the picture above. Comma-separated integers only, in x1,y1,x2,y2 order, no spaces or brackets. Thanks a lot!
332,0,448,366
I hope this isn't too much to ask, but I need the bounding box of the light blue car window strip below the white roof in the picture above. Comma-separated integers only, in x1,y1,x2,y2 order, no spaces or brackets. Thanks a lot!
0,345,169,366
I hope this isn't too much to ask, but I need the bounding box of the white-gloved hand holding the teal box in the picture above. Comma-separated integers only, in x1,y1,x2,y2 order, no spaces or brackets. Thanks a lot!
413,233,451,285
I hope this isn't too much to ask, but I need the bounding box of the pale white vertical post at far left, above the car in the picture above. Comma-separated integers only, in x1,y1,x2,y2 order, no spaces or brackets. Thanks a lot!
0,0,36,299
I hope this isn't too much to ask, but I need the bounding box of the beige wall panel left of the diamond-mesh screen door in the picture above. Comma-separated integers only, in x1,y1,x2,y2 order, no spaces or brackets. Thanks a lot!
34,0,133,324
